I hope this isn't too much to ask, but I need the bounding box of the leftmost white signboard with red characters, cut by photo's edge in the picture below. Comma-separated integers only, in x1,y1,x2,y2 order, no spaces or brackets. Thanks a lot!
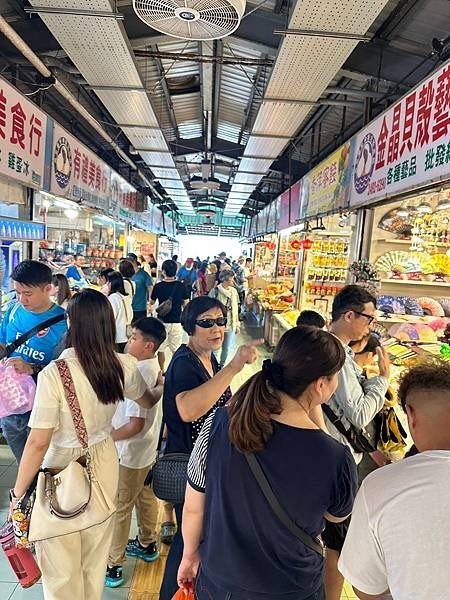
0,78,50,189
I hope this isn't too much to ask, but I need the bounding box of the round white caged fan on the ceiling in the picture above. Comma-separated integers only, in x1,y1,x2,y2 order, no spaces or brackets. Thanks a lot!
133,0,245,40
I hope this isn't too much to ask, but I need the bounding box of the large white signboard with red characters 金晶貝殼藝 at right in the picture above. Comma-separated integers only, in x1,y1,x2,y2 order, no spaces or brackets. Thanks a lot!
350,61,450,206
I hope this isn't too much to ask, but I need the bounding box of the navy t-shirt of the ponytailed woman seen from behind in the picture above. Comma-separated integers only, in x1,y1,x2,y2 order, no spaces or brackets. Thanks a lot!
188,408,357,600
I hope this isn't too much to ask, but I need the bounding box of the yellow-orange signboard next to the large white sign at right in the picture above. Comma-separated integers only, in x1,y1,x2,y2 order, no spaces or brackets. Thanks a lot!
303,141,352,217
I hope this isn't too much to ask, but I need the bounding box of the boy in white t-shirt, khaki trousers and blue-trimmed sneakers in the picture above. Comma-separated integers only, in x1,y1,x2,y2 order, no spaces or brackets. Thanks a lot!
105,317,166,587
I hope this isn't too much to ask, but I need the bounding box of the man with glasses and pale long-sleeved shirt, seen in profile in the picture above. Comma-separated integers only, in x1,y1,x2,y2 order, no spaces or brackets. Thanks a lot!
323,285,390,600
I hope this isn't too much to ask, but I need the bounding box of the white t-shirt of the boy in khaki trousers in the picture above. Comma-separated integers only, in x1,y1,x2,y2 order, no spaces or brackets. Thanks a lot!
113,357,162,469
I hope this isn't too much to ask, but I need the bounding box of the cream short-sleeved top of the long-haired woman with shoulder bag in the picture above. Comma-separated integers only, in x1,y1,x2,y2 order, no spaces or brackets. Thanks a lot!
28,348,147,448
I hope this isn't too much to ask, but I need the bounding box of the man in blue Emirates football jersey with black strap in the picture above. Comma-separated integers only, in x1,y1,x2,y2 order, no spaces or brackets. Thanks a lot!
0,260,67,462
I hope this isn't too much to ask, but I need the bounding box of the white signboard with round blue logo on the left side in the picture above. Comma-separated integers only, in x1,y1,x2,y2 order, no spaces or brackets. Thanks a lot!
50,123,111,213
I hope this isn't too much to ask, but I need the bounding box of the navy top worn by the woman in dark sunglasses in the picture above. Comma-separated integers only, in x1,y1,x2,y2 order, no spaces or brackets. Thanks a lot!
163,344,231,454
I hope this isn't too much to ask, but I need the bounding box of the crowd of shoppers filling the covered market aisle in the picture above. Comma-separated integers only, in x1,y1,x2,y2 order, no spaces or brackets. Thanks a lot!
0,255,450,600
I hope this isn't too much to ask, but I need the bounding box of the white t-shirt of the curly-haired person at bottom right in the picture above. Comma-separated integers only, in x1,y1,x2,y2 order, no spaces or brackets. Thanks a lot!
339,450,450,600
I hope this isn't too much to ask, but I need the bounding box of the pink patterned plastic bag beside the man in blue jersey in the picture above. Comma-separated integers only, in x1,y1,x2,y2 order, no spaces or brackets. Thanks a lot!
0,364,36,418
